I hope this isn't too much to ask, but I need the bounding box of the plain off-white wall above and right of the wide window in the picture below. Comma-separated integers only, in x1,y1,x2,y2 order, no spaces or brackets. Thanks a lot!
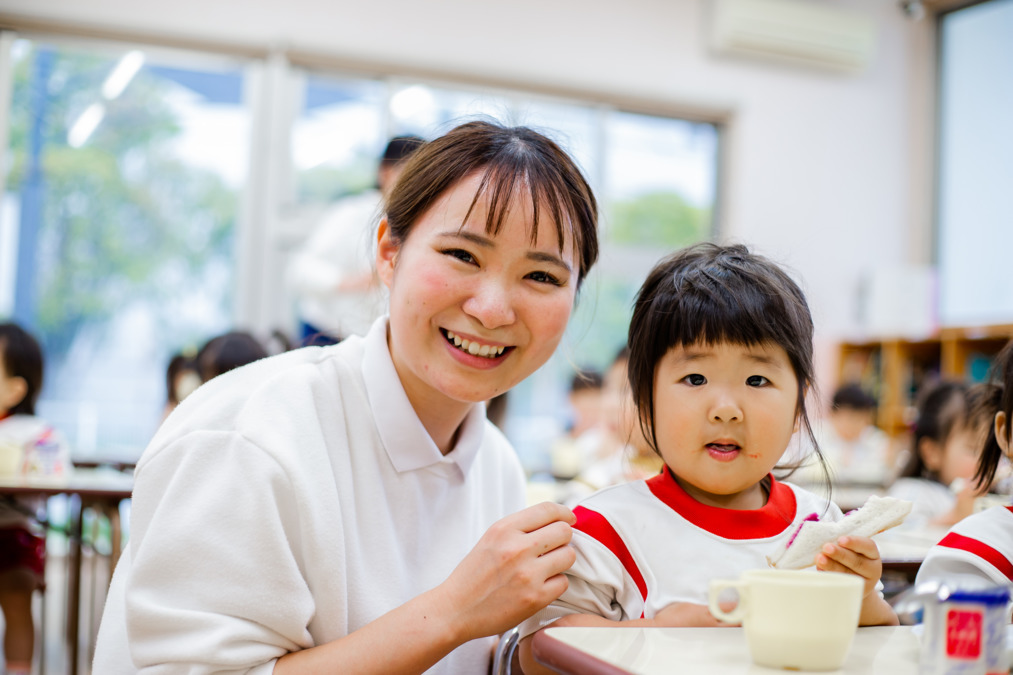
0,0,932,389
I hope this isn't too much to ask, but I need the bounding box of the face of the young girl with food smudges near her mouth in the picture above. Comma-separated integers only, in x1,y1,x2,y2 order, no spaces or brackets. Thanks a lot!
654,343,798,509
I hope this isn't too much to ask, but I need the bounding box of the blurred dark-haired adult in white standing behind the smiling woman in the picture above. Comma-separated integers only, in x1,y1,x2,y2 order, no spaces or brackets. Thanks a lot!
288,136,423,345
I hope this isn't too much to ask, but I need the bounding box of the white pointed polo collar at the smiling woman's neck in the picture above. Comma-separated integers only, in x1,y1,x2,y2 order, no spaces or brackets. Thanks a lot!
363,316,486,478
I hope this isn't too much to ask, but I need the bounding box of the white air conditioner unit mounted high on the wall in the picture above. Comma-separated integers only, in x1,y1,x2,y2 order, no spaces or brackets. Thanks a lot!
710,0,876,73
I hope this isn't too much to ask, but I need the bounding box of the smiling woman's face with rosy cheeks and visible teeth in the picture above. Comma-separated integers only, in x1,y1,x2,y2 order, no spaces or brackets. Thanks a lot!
377,173,577,415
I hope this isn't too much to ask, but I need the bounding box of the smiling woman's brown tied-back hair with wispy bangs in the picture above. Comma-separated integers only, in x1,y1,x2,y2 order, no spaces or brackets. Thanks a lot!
385,121,598,284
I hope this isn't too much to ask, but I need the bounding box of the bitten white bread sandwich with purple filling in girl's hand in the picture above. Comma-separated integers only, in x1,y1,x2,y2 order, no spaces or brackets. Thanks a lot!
767,496,912,570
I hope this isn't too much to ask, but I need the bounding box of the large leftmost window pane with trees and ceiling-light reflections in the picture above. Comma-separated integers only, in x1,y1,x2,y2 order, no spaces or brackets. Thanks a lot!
2,41,249,459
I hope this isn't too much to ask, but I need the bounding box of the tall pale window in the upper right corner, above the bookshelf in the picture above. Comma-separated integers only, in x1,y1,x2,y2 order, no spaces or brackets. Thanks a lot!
937,0,1013,325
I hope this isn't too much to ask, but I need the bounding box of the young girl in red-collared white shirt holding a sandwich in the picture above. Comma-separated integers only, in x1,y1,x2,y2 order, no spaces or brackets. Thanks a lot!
521,243,897,672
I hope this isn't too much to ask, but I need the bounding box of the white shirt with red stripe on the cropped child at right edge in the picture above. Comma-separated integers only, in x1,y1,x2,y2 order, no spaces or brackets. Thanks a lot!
916,507,1013,586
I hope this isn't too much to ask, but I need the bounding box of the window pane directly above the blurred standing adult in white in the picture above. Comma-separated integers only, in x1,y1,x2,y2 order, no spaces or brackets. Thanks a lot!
292,75,387,204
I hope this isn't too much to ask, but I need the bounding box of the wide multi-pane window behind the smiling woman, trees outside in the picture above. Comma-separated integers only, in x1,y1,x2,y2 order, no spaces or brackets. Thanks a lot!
0,34,719,470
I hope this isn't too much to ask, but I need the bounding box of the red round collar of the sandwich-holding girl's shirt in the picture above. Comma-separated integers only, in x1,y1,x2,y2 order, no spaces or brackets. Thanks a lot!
646,466,797,539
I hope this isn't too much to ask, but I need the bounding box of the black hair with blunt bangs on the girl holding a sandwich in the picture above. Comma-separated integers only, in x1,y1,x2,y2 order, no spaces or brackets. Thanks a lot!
628,243,829,482
